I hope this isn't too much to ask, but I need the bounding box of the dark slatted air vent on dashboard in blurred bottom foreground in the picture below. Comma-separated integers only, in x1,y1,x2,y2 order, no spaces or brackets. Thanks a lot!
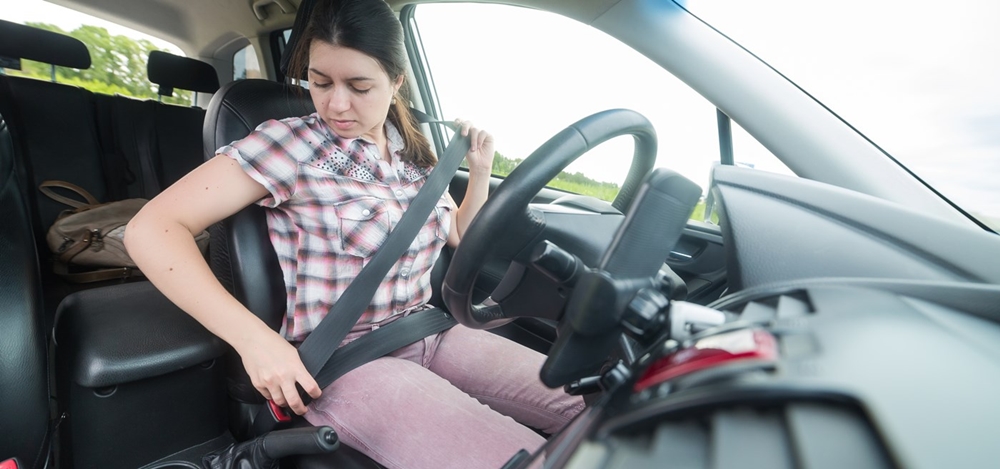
566,402,894,469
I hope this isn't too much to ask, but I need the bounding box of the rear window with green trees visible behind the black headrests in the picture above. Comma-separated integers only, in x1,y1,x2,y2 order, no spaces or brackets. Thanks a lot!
0,0,193,106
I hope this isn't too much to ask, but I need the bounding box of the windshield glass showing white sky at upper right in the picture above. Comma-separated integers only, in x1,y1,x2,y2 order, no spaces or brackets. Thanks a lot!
683,0,1000,231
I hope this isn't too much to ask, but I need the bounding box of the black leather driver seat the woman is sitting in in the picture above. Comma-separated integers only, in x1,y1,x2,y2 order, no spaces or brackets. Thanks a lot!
202,79,450,468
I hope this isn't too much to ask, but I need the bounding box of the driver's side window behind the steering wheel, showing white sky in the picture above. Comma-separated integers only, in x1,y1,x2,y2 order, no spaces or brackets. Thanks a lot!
414,3,792,219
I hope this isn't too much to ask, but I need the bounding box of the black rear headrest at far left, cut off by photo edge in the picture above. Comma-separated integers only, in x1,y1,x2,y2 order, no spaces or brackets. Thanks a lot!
0,20,90,70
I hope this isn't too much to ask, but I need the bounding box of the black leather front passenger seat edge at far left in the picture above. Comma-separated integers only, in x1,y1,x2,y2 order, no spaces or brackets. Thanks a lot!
0,112,49,468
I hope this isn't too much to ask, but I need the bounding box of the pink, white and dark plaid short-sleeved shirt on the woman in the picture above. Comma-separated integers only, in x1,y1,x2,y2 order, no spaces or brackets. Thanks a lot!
218,114,453,341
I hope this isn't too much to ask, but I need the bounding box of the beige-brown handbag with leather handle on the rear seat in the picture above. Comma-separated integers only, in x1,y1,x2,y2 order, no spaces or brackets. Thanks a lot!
38,181,209,283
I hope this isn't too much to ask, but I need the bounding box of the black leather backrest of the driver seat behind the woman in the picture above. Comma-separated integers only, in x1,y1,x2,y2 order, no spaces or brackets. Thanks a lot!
203,80,313,406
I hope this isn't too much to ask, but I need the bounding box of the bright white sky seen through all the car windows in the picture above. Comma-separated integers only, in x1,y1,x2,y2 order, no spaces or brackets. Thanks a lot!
0,0,1000,227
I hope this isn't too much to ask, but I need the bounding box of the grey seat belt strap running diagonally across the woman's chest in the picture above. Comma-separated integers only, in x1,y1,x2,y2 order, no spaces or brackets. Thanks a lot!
299,118,471,377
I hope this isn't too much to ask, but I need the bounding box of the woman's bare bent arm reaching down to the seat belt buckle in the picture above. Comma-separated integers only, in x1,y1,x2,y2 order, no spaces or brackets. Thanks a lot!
125,155,320,414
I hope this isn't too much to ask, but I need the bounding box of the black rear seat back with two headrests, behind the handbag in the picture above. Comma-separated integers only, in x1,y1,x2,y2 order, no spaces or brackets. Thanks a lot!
0,20,219,326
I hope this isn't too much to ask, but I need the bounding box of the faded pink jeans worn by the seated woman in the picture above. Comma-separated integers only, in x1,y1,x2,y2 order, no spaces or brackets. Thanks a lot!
305,325,584,469
